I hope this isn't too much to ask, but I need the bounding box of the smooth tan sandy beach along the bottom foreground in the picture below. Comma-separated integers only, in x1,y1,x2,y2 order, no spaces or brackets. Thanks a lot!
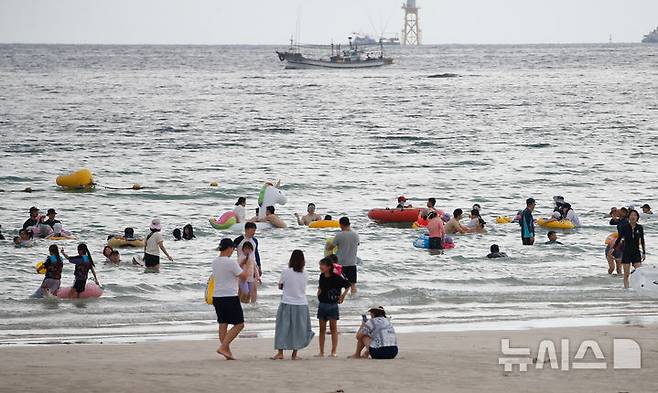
0,326,658,393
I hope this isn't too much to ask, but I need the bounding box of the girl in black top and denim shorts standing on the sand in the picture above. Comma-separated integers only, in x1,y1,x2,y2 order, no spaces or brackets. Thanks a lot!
318,257,352,357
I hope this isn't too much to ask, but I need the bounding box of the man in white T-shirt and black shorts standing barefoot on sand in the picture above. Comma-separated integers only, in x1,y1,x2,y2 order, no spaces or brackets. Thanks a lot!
212,239,253,360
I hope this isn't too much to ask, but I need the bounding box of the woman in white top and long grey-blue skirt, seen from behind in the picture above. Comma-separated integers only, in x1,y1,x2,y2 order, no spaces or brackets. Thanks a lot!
272,250,315,360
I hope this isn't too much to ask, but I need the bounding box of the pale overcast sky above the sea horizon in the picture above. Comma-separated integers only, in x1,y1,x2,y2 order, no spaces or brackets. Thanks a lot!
0,0,658,44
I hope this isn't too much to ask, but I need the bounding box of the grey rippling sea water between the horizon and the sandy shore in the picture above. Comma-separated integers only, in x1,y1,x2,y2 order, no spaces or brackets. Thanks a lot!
0,45,658,343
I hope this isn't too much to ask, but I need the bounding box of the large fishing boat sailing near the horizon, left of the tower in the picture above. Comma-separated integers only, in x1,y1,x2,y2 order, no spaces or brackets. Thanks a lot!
276,37,393,70
